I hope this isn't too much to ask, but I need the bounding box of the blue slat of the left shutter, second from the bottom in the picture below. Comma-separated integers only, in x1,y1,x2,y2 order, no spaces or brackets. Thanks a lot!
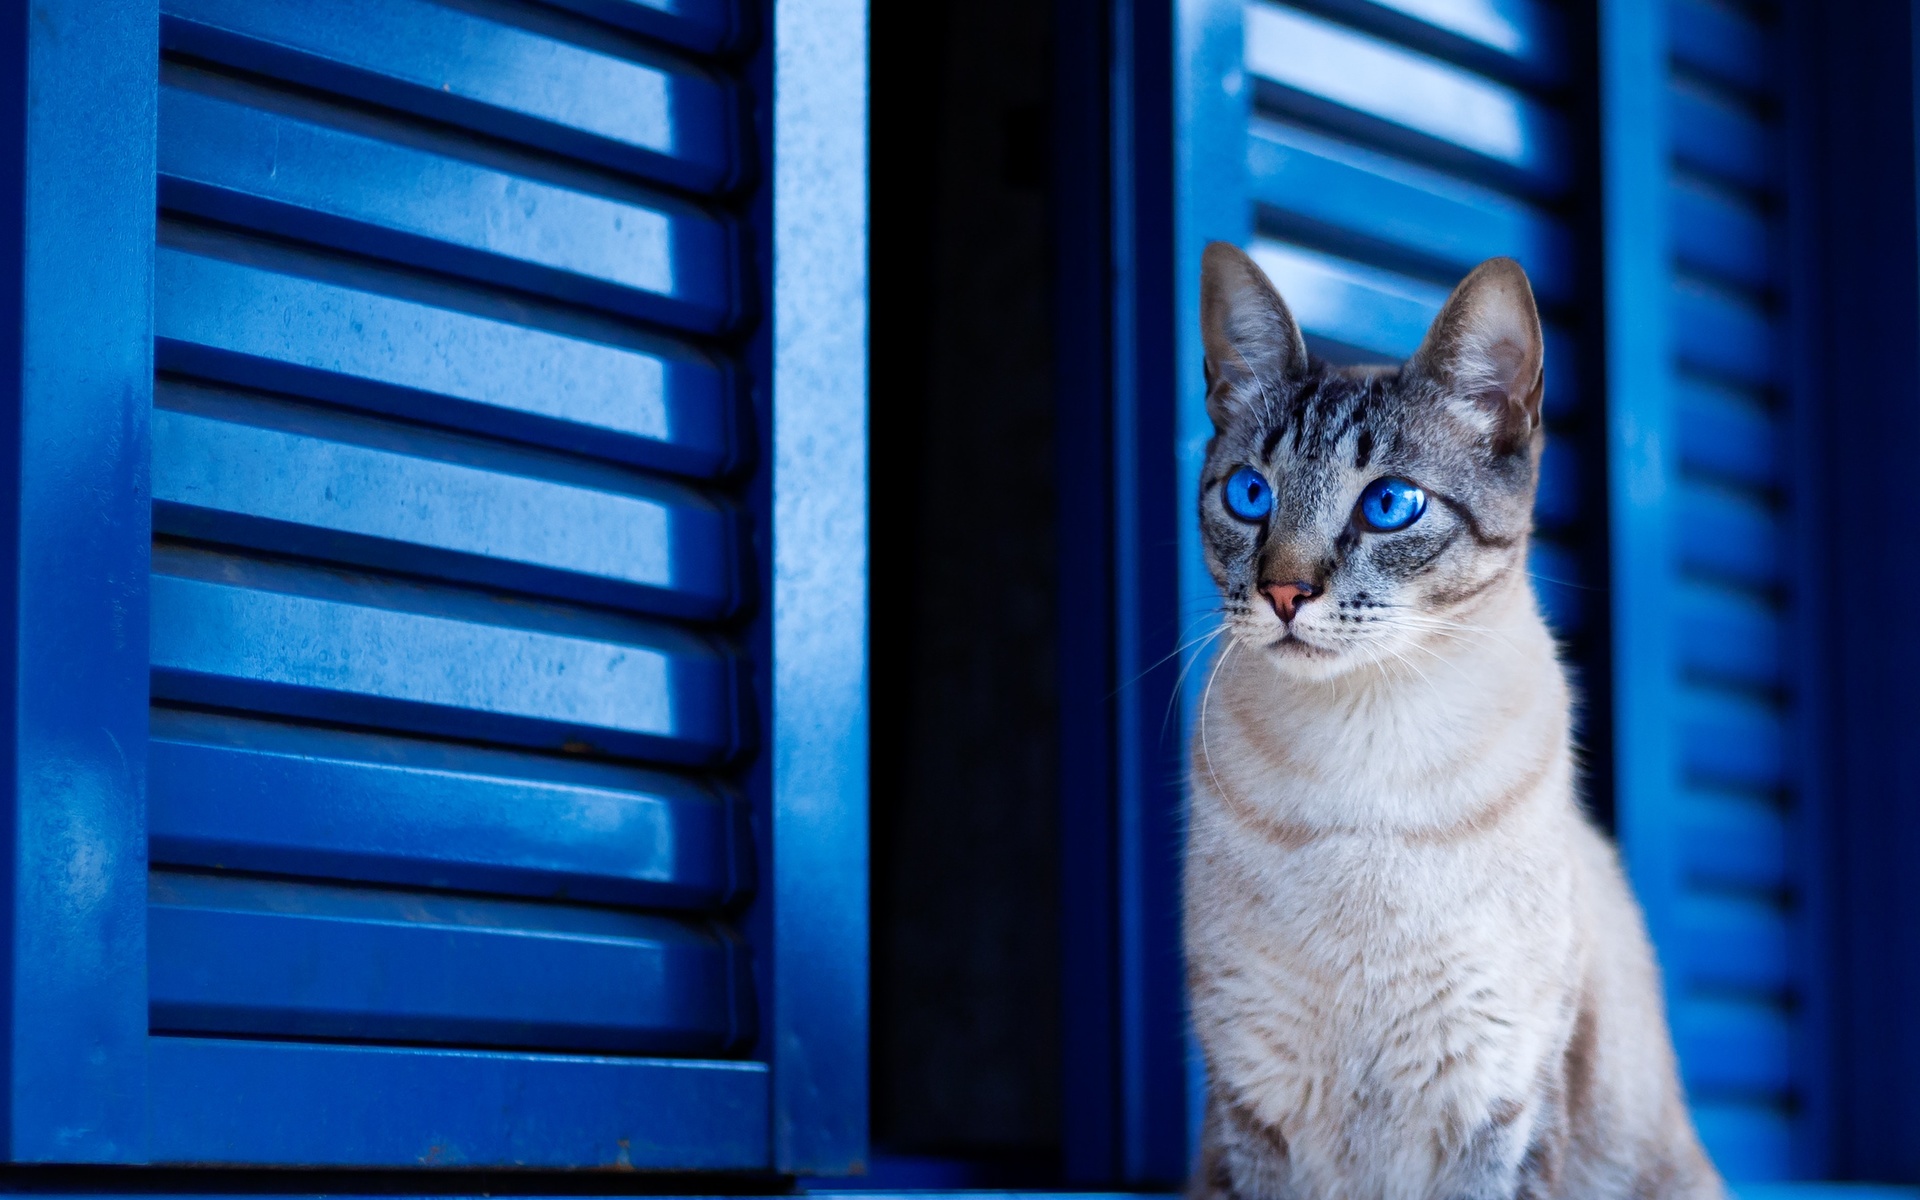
148,708,753,910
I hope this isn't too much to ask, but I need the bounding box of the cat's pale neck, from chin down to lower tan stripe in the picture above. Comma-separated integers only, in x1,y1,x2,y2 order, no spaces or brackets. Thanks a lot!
1196,576,1569,833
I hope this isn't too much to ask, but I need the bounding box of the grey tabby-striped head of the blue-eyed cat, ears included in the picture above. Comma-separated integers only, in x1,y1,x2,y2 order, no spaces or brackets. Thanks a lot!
1200,242,1544,678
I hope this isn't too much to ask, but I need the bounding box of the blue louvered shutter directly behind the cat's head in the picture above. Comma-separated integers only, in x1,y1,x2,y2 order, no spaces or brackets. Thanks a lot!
1179,0,1601,683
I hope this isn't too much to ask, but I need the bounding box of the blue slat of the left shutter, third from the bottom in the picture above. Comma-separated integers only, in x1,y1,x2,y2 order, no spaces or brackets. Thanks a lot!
152,549,745,764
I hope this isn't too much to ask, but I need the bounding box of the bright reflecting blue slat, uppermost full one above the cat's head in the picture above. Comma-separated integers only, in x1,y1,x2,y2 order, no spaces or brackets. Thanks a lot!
1246,0,1569,190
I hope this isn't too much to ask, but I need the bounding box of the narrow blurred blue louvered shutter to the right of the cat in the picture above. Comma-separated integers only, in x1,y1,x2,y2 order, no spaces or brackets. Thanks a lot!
1601,0,1822,1181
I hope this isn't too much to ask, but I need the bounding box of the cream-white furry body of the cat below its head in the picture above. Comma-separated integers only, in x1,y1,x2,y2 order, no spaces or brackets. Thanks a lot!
1187,570,1722,1200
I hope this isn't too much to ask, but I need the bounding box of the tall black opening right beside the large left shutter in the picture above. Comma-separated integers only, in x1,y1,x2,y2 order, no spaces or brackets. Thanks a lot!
872,0,1071,1183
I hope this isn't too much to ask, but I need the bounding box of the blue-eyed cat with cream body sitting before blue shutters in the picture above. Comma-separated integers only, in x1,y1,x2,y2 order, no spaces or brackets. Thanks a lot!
1185,244,1724,1200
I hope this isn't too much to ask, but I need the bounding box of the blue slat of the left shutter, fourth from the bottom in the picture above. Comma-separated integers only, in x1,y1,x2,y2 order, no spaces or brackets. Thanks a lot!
154,384,745,618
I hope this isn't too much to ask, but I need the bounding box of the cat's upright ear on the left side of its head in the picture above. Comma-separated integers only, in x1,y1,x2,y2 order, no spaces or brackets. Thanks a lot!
1200,242,1308,430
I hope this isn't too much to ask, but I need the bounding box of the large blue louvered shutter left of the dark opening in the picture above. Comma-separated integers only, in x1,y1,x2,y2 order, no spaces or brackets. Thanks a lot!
6,0,866,1171
